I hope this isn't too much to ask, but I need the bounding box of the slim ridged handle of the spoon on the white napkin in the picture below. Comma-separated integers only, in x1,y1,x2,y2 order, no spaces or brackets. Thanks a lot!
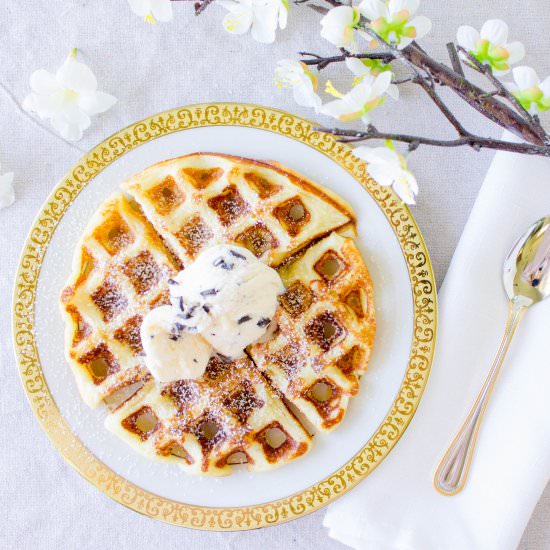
434,302,527,496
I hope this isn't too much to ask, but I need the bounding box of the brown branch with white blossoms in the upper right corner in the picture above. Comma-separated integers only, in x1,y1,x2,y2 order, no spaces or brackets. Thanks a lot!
275,0,550,204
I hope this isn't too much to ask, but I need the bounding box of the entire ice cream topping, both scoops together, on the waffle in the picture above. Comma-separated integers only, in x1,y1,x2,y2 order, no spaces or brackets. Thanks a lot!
141,245,285,382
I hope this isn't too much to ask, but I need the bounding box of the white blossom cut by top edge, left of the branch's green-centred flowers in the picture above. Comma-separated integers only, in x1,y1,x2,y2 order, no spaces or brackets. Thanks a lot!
218,0,288,44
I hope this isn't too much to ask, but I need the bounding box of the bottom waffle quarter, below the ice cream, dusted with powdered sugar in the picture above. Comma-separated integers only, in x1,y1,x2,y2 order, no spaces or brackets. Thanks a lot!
106,357,310,476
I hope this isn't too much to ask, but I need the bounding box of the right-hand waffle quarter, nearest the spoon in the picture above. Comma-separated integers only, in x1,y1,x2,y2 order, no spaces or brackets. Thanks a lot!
248,233,376,430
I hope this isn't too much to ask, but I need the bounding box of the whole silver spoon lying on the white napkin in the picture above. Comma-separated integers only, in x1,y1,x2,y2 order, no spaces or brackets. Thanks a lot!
434,216,550,495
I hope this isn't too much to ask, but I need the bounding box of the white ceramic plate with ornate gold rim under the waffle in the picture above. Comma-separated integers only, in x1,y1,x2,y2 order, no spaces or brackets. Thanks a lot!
14,104,435,529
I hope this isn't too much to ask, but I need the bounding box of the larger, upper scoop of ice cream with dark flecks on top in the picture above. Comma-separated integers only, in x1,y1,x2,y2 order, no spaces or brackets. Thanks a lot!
170,245,285,359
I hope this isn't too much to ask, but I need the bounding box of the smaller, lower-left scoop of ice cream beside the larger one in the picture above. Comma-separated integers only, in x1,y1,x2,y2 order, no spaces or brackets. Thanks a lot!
140,305,212,382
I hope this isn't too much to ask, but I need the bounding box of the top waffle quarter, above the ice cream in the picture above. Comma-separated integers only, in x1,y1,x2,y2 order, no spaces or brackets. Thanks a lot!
122,153,354,266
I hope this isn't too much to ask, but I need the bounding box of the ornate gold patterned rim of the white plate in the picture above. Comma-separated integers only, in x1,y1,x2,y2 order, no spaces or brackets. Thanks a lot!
12,102,437,531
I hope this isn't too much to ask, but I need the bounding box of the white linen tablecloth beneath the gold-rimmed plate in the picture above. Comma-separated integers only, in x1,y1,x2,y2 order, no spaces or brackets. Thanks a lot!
0,0,550,550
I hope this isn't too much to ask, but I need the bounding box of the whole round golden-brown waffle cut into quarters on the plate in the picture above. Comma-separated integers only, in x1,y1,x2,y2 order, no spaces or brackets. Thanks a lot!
61,154,375,476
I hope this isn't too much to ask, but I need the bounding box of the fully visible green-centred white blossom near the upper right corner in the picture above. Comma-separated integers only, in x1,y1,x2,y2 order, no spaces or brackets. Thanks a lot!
456,19,525,74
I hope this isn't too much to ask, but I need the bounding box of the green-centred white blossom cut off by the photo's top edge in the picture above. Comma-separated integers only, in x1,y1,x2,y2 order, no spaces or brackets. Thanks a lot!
359,0,432,49
